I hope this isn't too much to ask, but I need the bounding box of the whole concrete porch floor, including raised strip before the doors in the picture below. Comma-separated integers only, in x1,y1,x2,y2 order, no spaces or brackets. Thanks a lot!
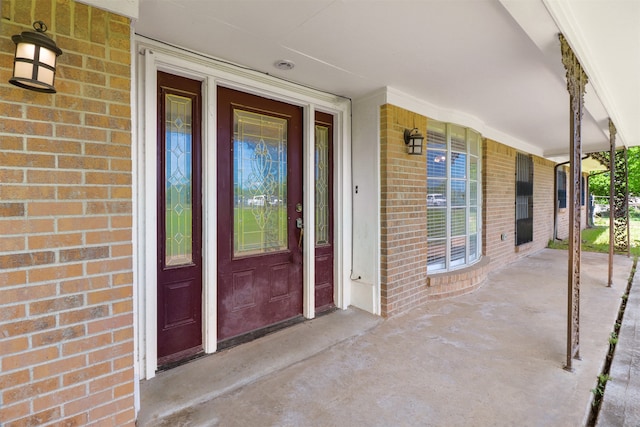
138,249,638,427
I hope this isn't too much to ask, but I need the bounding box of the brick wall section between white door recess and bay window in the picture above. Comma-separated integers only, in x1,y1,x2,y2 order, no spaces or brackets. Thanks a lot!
380,104,429,316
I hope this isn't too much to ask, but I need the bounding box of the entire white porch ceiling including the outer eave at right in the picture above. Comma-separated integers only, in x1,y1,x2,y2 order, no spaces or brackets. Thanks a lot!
134,0,640,161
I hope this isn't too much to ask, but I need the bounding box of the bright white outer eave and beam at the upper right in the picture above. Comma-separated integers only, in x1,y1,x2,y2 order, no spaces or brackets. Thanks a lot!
500,0,640,150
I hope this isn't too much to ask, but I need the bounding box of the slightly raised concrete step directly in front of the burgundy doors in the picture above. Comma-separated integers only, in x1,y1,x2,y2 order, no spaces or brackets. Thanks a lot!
138,309,382,426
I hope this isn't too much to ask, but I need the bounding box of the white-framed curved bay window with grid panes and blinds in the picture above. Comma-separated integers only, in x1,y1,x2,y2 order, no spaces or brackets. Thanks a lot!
427,120,482,272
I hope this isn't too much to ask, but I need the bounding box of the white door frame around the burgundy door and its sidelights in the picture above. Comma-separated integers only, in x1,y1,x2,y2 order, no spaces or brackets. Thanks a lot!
134,37,352,379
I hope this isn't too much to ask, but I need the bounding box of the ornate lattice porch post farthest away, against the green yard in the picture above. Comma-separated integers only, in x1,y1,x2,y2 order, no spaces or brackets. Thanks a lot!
613,148,629,255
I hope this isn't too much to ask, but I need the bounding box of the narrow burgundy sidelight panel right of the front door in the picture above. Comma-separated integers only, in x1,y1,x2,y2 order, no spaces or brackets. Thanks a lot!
314,112,334,313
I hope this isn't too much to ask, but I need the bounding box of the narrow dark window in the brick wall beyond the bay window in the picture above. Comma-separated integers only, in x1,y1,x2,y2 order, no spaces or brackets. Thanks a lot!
516,153,533,245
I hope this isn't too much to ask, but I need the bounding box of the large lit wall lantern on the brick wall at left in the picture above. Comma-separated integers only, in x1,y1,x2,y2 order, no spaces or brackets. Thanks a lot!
9,21,62,93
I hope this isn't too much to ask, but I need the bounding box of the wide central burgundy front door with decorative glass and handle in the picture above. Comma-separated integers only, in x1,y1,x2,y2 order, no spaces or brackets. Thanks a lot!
217,88,303,341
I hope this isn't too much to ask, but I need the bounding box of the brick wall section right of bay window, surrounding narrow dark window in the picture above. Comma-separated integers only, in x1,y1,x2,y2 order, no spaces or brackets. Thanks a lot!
482,139,555,265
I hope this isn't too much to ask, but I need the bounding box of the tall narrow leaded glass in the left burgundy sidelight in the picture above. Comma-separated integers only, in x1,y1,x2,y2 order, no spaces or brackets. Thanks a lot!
164,94,193,266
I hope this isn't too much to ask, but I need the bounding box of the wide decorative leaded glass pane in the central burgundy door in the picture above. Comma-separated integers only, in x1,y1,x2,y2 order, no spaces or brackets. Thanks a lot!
233,109,288,257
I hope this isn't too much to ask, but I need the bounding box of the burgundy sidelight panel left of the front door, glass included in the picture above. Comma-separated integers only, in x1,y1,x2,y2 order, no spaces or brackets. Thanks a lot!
157,72,202,366
